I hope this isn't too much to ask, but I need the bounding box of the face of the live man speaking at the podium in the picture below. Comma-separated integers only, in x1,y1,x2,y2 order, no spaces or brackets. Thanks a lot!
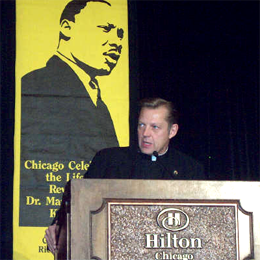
138,106,178,154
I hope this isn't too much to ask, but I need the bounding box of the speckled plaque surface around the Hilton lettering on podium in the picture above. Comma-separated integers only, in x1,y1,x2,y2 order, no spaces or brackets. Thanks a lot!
108,203,238,260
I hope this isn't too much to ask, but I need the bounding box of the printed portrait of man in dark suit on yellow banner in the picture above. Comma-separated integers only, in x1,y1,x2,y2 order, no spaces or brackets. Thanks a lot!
20,0,124,226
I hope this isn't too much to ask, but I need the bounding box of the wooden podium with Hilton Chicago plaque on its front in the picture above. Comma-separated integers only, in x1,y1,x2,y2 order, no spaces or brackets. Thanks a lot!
58,179,260,260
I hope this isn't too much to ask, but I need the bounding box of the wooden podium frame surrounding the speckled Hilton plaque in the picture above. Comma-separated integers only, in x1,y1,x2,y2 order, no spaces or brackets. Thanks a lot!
55,179,260,260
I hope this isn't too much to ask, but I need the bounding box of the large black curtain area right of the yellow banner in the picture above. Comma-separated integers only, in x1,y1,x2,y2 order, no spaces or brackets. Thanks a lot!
132,0,260,180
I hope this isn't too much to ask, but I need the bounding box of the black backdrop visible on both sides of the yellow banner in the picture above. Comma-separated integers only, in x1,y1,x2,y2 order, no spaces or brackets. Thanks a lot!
0,0,260,259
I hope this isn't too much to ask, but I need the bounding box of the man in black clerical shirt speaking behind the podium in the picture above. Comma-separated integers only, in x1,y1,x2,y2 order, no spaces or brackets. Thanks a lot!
46,98,206,252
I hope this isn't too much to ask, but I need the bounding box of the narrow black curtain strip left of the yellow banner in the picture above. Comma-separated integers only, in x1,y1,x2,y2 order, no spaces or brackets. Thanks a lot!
0,0,15,259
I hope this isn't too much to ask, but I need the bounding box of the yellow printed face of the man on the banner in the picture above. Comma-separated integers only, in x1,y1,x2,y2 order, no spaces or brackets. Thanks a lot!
68,2,124,75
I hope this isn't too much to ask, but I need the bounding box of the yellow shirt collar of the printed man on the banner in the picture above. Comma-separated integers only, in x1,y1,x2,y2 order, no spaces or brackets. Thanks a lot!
56,51,98,106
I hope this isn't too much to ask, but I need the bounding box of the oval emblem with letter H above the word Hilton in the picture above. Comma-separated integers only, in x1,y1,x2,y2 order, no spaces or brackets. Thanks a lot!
157,208,189,231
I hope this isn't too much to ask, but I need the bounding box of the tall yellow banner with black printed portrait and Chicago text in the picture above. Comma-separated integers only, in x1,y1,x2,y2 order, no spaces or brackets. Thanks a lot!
13,0,129,260
